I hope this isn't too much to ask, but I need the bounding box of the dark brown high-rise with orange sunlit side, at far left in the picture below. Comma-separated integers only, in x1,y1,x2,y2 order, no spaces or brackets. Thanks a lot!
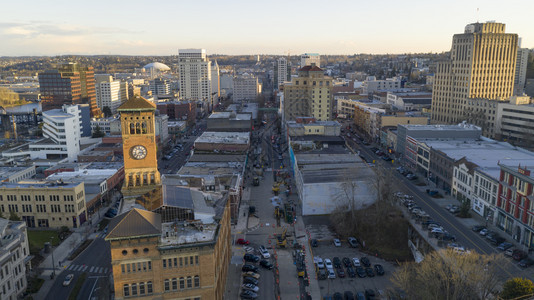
39,63,101,117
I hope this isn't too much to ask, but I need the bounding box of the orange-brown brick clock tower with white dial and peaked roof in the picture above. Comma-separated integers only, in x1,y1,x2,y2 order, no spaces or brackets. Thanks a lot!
118,96,161,197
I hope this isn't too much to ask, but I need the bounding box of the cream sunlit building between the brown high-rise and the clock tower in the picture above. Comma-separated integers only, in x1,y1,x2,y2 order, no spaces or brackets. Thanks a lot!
95,74,124,114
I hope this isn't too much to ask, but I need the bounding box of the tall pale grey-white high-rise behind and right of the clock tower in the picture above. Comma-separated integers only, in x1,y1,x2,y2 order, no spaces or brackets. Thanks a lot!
178,49,211,101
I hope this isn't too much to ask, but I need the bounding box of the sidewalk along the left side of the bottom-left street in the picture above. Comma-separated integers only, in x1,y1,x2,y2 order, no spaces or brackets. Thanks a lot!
32,195,118,300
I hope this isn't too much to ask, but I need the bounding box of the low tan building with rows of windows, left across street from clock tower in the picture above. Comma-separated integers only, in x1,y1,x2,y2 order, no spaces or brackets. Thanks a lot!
0,182,87,228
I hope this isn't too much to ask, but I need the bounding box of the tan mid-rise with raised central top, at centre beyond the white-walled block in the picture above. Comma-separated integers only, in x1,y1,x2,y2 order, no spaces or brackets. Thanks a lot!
283,66,333,121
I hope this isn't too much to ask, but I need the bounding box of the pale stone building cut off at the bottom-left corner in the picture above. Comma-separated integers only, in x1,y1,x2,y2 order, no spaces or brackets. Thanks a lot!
0,218,30,300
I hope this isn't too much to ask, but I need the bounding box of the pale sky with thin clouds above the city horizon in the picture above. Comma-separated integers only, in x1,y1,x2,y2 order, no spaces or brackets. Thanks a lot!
0,0,534,56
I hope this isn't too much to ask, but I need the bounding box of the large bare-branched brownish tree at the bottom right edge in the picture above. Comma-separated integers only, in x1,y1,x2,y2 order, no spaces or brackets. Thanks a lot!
390,249,506,299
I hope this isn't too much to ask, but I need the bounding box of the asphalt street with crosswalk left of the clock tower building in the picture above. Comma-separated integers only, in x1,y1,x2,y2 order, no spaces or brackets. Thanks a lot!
45,237,111,300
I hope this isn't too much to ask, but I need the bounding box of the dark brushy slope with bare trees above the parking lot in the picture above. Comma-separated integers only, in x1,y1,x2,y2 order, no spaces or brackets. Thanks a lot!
331,204,413,261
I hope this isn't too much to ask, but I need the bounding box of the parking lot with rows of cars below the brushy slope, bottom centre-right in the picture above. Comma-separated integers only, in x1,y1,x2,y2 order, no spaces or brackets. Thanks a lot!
312,240,395,298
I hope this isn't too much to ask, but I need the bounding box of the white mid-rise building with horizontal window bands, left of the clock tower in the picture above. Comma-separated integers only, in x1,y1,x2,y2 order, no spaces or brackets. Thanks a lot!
30,105,82,162
